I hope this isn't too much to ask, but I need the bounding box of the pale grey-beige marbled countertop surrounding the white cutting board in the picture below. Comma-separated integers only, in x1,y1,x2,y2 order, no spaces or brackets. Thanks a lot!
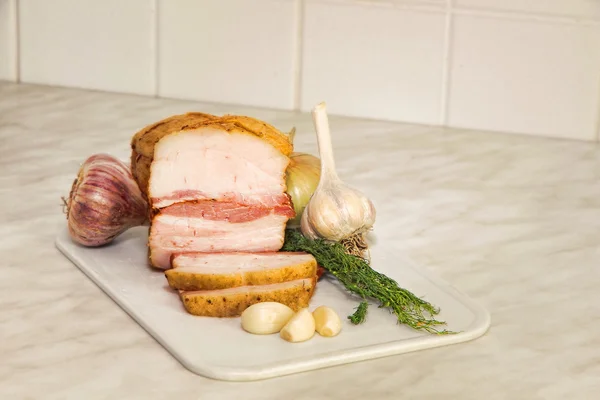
0,83,600,400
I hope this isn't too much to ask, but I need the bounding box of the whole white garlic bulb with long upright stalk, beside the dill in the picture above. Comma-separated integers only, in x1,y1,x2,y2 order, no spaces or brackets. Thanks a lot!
300,102,376,257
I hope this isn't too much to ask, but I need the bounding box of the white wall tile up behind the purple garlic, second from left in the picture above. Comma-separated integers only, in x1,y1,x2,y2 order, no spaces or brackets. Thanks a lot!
19,0,155,94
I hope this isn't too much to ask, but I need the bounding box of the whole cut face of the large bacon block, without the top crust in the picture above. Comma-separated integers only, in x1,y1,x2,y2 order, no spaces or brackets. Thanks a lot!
148,127,295,269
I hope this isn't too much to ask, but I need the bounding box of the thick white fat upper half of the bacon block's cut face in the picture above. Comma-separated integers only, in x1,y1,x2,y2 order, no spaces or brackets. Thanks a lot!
148,127,289,208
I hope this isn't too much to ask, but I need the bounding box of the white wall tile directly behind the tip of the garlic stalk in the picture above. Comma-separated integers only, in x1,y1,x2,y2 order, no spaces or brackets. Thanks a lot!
301,1,445,124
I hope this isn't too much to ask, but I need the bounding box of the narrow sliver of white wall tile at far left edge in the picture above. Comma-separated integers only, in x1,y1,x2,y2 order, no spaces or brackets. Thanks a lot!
0,0,17,81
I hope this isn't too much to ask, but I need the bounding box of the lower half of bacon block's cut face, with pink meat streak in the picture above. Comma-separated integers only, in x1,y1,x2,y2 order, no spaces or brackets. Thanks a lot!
149,201,293,269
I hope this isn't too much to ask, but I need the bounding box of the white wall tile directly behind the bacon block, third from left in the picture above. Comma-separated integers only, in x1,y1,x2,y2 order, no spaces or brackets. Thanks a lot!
158,0,297,109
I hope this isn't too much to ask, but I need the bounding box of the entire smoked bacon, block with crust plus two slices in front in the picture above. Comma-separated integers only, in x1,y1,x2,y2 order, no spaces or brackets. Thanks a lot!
131,113,318,317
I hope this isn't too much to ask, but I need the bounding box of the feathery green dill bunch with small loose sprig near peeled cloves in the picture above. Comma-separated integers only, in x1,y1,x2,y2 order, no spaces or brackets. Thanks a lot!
282,229,454,334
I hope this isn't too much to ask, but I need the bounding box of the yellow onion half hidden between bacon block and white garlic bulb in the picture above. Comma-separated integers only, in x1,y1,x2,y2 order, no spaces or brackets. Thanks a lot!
285,152,321,227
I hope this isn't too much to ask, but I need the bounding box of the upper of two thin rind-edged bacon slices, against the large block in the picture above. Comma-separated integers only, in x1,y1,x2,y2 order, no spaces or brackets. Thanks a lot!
165,252,317,290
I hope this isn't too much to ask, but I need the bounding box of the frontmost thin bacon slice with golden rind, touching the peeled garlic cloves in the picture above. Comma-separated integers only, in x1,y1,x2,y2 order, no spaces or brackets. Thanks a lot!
180,275,317,317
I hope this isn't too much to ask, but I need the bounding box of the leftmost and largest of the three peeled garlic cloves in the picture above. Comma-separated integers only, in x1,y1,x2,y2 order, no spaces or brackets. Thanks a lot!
241,301,294,335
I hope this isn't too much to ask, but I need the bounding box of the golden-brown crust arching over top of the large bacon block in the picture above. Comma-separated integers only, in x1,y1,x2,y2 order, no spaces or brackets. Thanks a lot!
131,112,293,196
